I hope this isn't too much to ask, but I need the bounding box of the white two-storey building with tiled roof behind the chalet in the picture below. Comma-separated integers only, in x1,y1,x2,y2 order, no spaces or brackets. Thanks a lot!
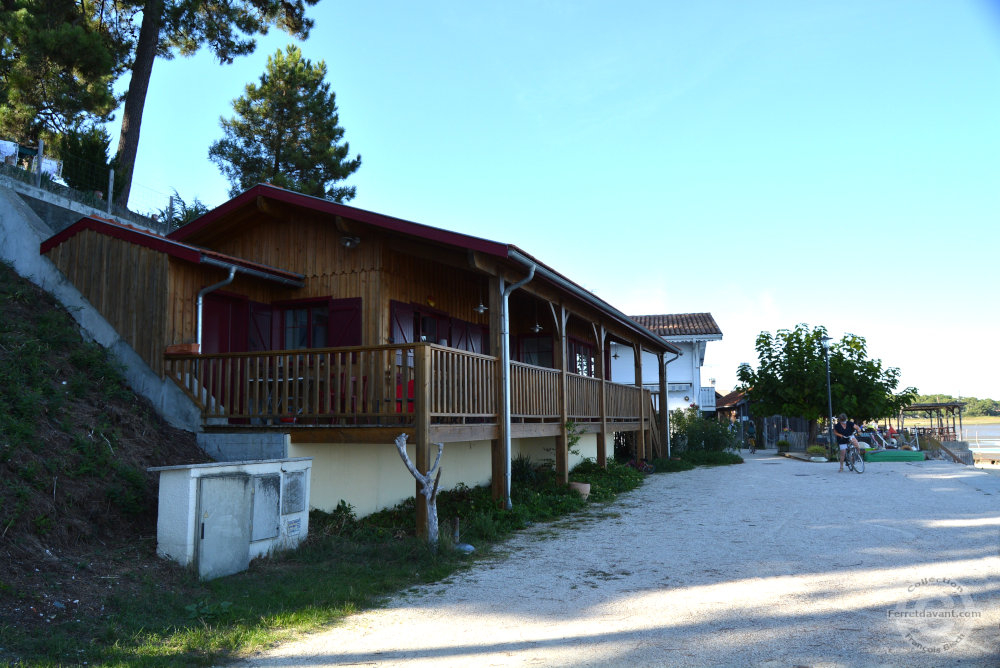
611,313,722,412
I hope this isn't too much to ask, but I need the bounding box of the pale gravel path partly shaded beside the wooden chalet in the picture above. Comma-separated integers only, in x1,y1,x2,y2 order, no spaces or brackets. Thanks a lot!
241,452,1000,668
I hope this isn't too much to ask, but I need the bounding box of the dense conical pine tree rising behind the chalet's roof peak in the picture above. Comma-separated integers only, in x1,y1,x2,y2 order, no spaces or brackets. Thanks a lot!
208,45,361,202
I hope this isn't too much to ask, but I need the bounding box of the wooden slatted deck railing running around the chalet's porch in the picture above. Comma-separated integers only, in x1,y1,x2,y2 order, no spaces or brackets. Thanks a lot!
164,343,649,426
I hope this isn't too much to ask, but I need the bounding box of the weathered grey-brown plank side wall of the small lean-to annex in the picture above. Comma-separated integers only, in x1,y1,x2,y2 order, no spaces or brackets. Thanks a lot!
48,230,168,374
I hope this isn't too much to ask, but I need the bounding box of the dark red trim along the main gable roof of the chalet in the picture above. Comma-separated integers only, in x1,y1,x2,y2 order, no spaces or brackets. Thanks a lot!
167,184,507,258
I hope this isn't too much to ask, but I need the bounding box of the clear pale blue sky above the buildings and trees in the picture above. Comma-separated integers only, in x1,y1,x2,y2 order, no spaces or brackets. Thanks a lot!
110,0,1000,399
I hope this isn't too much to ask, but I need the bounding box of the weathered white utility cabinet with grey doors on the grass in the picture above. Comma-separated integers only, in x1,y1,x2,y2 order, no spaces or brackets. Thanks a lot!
149,457,312,580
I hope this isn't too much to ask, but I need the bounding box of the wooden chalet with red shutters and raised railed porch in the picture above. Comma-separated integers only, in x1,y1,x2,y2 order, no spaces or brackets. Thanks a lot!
41,185,676,524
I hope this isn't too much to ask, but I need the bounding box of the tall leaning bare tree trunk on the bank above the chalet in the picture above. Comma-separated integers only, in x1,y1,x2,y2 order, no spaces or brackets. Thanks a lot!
114,0,163,207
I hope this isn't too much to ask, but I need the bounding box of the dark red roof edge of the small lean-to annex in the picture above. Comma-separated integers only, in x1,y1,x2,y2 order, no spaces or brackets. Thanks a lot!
40,216,305,287
